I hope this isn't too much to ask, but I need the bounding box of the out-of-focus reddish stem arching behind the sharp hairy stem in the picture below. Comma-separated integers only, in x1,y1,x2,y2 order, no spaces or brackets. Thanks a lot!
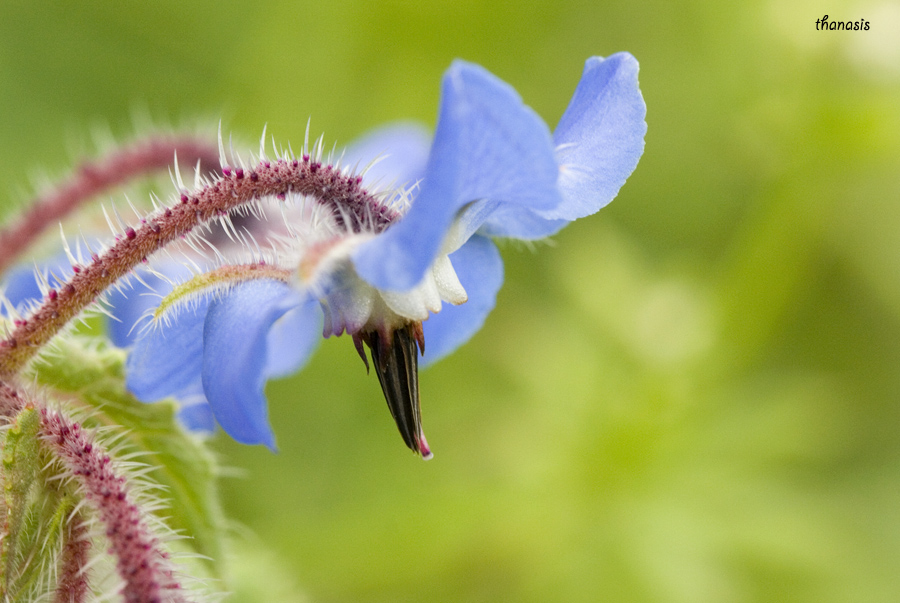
0,136,219,272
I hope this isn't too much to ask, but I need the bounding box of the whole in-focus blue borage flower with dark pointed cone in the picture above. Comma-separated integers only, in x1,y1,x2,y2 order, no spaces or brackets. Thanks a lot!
128,53,646,458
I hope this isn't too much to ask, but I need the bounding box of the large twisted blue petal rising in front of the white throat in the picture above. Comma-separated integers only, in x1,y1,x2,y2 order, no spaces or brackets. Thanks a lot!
353,61,561,291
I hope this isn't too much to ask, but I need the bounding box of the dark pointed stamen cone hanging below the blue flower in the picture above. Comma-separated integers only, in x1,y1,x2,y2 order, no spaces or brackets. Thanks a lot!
362,323,431,459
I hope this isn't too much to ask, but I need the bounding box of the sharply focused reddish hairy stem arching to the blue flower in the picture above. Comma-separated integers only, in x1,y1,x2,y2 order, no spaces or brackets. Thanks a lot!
0,155,397,379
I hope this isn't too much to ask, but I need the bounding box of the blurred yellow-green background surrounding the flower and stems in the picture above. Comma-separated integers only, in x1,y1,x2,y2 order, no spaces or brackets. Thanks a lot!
0,0,900,602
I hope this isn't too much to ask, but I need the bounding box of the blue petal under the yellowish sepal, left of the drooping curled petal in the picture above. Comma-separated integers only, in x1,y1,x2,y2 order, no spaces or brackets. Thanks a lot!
126,298,210,402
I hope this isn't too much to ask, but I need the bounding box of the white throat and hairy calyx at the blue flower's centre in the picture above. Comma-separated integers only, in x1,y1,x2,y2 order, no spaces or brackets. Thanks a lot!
142,192,471,344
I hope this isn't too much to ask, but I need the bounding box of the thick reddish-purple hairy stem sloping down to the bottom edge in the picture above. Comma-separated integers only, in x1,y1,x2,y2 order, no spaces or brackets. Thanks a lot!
41,408,184,603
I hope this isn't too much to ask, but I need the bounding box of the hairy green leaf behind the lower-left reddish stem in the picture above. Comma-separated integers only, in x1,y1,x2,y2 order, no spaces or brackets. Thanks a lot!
29,335,224,576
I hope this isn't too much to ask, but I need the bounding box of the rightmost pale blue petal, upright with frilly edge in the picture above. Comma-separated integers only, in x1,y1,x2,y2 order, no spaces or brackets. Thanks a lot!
538,52,647,220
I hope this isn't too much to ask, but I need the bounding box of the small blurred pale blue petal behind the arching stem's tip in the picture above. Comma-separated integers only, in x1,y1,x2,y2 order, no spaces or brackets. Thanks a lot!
342,122,431,186
